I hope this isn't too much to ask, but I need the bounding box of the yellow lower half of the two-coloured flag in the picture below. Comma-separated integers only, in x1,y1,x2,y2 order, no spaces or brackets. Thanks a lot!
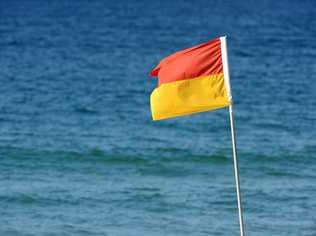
150,74,230,120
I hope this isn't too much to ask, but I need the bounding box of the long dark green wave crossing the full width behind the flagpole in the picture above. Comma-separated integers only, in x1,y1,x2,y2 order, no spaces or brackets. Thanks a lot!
0,146,316,168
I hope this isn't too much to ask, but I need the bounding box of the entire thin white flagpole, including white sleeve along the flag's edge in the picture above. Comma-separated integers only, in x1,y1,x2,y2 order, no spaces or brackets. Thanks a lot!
220,36,245,236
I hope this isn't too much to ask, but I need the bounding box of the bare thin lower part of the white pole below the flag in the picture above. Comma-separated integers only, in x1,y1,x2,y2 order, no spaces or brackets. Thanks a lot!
229,104,245,236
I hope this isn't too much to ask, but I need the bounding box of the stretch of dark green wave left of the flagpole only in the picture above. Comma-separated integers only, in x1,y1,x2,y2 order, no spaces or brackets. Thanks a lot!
0,146,228,164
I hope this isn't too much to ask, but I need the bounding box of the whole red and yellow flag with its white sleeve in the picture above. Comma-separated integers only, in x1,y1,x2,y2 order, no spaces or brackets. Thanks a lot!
150,37,232,120
